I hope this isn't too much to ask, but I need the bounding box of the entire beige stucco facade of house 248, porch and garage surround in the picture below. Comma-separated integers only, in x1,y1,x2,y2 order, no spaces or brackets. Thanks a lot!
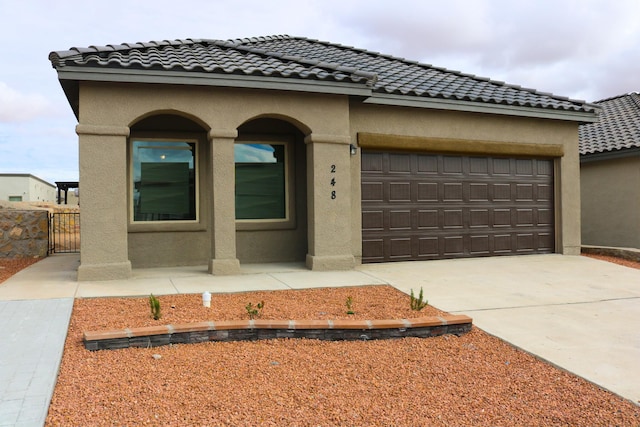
77,83,580,280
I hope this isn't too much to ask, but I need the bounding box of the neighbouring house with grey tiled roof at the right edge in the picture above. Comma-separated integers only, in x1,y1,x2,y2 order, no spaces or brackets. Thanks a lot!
580,92,640,249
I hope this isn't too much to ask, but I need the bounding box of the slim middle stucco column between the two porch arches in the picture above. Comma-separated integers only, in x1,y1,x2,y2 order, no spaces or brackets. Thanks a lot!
208,129,240,275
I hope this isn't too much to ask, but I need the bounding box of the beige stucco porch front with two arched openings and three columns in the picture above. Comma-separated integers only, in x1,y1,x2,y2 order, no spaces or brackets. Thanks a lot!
77,83,354,280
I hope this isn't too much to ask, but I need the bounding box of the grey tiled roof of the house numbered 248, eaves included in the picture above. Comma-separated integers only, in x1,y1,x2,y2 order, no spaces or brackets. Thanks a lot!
49,35,598,122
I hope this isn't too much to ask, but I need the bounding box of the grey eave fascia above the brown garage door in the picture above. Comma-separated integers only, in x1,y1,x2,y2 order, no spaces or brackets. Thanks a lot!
363,93,598,123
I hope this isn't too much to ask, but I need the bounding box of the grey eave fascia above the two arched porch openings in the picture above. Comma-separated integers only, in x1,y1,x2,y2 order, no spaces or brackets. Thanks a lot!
58,67,371,96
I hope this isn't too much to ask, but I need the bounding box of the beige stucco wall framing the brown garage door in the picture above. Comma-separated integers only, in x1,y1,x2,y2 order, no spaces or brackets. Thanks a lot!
350,104,580,259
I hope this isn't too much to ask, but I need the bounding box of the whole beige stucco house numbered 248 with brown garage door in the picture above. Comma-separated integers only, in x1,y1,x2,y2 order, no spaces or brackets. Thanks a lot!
49,36,598,280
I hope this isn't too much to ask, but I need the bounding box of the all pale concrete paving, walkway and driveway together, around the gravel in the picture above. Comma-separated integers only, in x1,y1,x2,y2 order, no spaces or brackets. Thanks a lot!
0,255,640,426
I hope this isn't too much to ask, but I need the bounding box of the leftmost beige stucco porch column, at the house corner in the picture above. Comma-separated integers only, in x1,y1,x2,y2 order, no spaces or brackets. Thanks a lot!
76,124,131,281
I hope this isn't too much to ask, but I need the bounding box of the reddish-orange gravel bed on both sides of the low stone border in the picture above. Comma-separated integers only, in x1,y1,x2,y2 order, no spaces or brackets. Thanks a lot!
46,286,640,426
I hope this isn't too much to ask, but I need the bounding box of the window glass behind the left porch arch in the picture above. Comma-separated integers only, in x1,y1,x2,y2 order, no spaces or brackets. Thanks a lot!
132,140,196,221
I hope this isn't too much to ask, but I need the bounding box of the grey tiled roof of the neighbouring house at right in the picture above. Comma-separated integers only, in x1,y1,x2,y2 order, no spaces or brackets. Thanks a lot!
579,92,640,156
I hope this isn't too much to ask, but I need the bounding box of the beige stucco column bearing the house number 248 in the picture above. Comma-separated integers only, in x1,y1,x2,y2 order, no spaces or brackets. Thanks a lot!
305,134,355,270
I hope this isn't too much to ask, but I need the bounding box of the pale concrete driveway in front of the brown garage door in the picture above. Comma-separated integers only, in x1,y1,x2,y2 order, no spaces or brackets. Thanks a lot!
358,255,640,404
